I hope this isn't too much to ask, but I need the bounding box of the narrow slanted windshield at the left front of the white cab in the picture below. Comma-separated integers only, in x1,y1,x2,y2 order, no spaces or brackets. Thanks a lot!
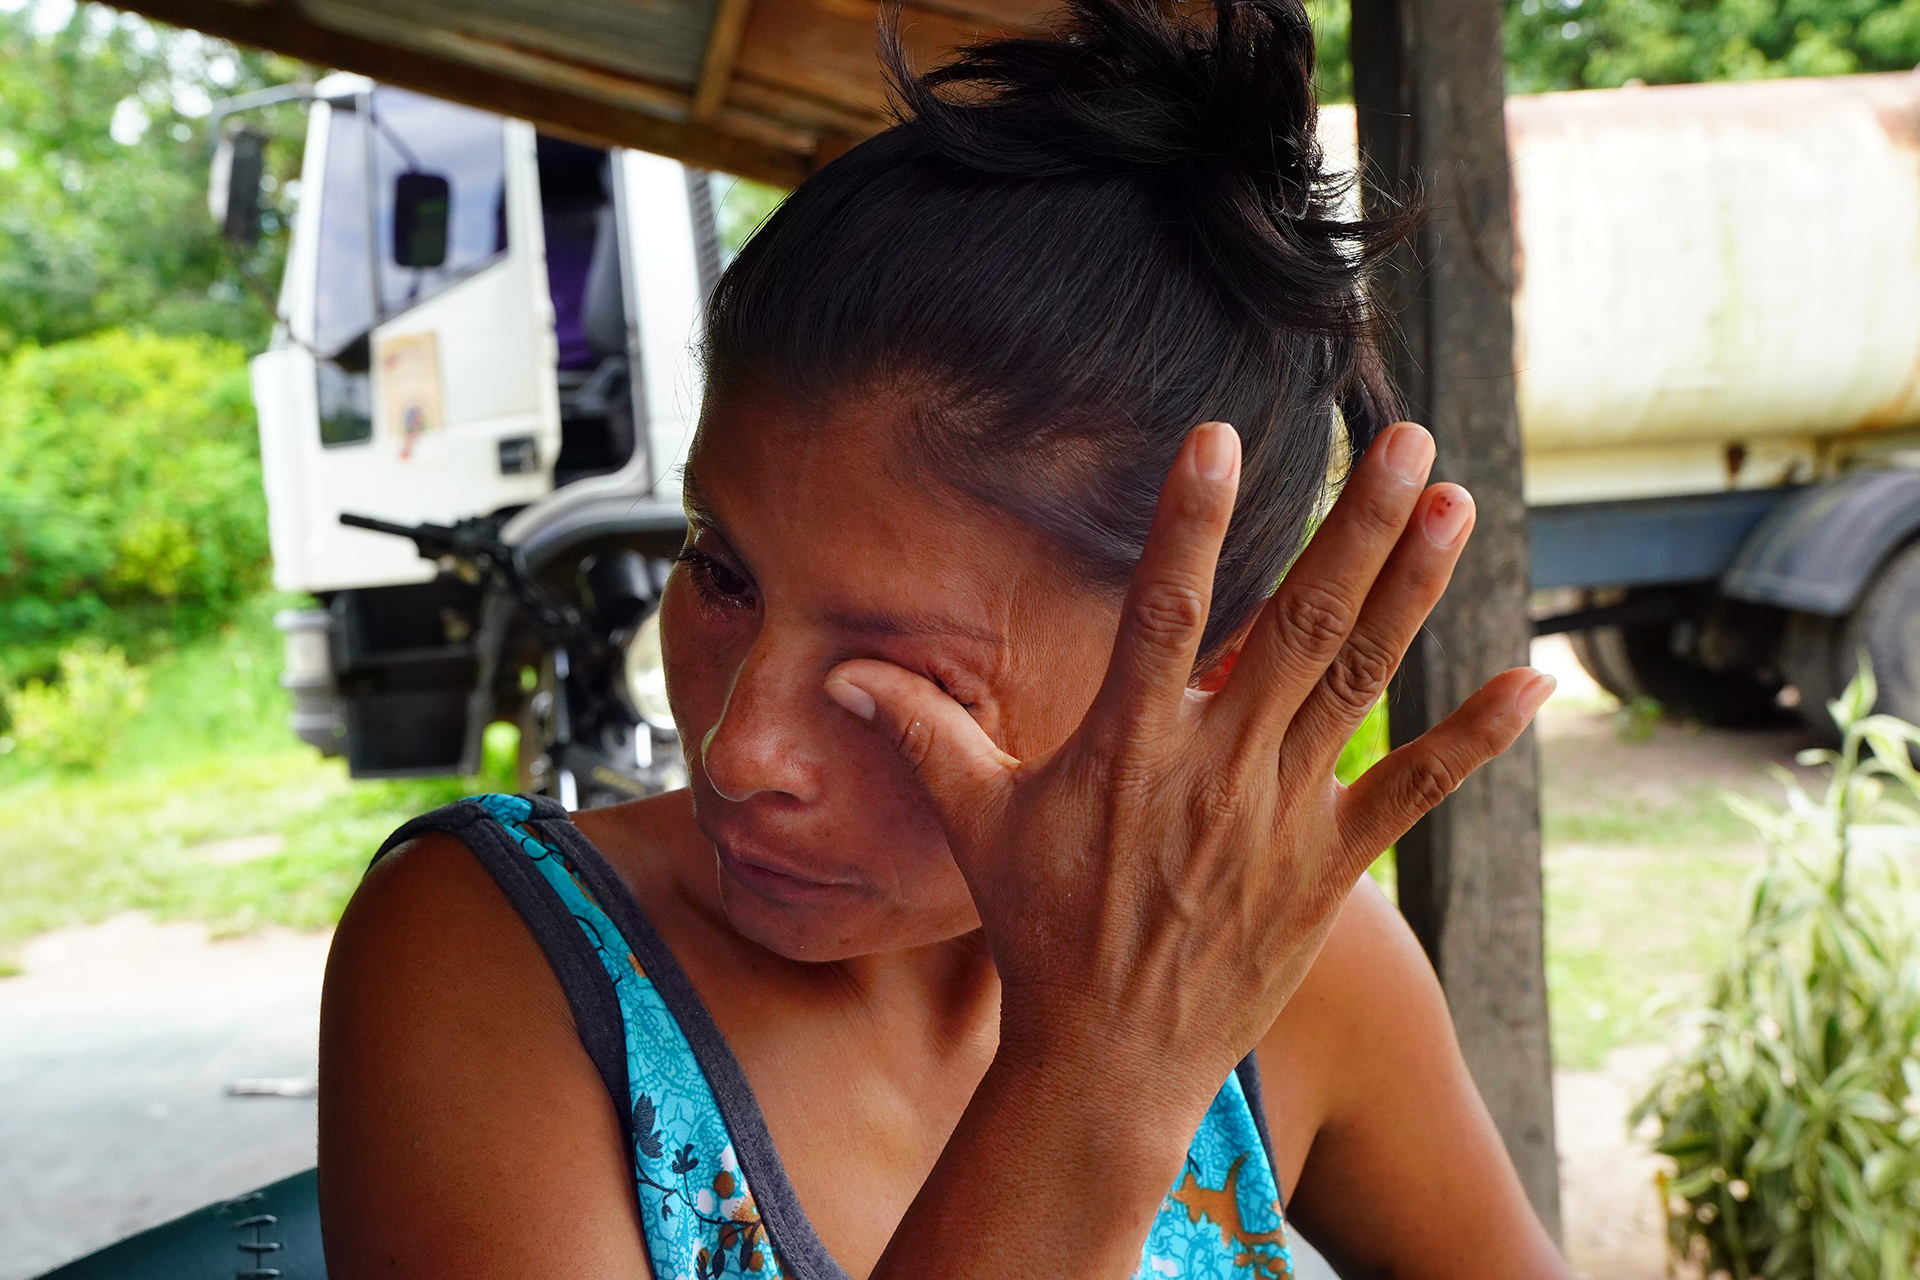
313,98,374,445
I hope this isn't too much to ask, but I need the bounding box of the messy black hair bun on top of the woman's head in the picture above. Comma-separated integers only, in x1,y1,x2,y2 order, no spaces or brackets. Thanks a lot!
883,0,1394,332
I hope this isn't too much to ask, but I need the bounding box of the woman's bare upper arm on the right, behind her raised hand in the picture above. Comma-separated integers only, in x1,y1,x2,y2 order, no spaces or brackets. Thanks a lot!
1260,877,1569,1280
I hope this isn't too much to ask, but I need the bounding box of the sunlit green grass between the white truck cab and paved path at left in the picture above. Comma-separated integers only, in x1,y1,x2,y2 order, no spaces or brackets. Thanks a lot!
0,597,513,965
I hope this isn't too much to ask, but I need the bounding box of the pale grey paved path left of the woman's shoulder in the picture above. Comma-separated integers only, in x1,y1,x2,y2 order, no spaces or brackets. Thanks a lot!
0,917,326,1280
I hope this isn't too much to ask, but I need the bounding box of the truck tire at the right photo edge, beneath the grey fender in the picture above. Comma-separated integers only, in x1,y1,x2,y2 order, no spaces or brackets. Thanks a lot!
1782,543,1920,739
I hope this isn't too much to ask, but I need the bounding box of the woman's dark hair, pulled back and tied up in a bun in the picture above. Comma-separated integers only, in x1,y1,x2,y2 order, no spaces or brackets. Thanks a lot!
705,0,1402,668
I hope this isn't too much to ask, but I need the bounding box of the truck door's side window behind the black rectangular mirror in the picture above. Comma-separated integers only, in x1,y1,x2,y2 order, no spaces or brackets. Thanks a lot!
372,84,507,319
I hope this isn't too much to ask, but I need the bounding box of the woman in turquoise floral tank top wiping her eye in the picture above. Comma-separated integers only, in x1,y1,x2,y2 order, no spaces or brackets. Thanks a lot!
321,0,1565,1280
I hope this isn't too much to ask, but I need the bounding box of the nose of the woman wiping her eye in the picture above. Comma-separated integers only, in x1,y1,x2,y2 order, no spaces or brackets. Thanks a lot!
701,637,826,800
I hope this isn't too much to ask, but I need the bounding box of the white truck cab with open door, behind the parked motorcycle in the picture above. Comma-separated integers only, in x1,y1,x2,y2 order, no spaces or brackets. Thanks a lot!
252,75,720,777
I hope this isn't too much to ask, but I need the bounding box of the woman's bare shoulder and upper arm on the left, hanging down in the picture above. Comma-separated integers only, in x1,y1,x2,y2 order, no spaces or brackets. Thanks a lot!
321,835,651,1280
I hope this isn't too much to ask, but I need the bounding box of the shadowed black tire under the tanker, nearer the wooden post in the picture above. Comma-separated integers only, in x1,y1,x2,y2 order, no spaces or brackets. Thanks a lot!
1569,594,1786,729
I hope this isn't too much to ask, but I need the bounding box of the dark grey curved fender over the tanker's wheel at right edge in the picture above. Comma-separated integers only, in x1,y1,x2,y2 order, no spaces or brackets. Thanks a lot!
1720,470,1920,616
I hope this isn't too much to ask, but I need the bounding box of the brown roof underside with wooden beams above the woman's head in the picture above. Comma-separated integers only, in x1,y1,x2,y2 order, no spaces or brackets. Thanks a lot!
121,0,1048,186
